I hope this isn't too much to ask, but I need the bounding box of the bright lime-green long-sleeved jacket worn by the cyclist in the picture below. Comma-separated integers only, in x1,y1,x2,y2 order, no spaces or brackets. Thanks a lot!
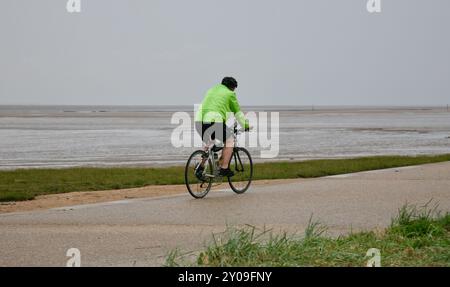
195,84,248,128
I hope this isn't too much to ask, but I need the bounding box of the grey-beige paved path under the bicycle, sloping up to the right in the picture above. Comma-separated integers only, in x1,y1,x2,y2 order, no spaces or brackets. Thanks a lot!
0,162,450,266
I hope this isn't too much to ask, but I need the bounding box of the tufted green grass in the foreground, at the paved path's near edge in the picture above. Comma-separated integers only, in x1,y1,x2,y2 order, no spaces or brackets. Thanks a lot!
166,202,450,267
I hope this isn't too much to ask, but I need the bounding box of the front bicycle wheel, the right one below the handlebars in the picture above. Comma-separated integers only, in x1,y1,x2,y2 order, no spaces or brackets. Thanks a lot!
228,147,253,194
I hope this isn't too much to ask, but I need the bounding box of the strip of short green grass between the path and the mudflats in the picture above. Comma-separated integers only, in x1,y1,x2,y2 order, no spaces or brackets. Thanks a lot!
0,154,450,204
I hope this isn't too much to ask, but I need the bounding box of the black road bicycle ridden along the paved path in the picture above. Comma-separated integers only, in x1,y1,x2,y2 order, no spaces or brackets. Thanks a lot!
184,122,253,198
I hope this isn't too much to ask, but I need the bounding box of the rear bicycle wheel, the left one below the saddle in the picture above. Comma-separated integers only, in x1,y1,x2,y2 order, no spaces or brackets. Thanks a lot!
184,150,213,198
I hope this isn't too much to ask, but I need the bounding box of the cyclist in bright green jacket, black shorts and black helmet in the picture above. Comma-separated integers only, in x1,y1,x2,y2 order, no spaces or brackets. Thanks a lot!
195,77,250,177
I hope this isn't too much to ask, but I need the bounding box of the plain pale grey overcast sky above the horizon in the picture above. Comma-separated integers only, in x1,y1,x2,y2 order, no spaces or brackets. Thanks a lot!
0,0,450,105
